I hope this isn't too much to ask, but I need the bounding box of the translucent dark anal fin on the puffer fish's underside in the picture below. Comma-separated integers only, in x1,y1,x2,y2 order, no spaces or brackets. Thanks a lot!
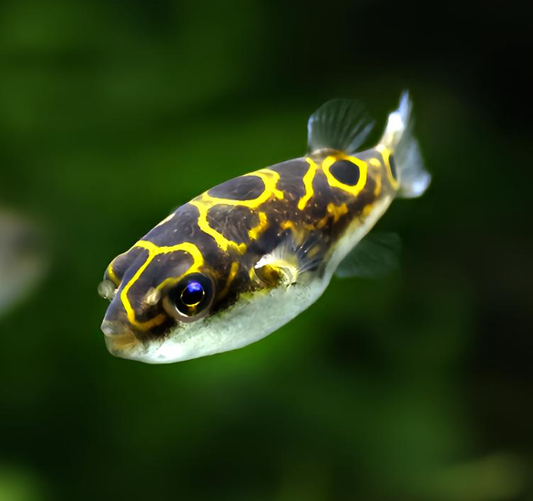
336,231,401,278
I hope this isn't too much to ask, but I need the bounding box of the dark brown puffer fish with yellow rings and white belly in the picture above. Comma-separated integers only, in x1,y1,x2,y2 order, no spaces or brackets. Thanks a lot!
98,93,430,364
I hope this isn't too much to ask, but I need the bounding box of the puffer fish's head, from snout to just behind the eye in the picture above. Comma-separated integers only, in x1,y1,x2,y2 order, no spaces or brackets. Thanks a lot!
98,236,223,363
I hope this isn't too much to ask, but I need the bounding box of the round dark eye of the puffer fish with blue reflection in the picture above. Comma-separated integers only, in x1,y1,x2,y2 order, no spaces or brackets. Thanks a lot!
163,273,215,322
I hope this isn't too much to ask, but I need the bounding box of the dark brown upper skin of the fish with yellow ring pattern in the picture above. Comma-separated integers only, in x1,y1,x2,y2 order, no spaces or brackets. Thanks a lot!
104,146,398,344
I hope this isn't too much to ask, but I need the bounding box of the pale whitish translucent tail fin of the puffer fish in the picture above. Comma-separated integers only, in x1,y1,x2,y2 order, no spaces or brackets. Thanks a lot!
379,91,431,198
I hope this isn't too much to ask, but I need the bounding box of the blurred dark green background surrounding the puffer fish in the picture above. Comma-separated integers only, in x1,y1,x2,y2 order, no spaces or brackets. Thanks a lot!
0,0,533,501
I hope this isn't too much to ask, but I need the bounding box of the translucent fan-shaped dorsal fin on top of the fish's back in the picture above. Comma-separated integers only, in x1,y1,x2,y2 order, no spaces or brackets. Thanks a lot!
307,99,374,154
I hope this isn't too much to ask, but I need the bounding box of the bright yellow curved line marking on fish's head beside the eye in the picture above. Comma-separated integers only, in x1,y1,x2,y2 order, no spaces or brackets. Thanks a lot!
120,240,204,330
